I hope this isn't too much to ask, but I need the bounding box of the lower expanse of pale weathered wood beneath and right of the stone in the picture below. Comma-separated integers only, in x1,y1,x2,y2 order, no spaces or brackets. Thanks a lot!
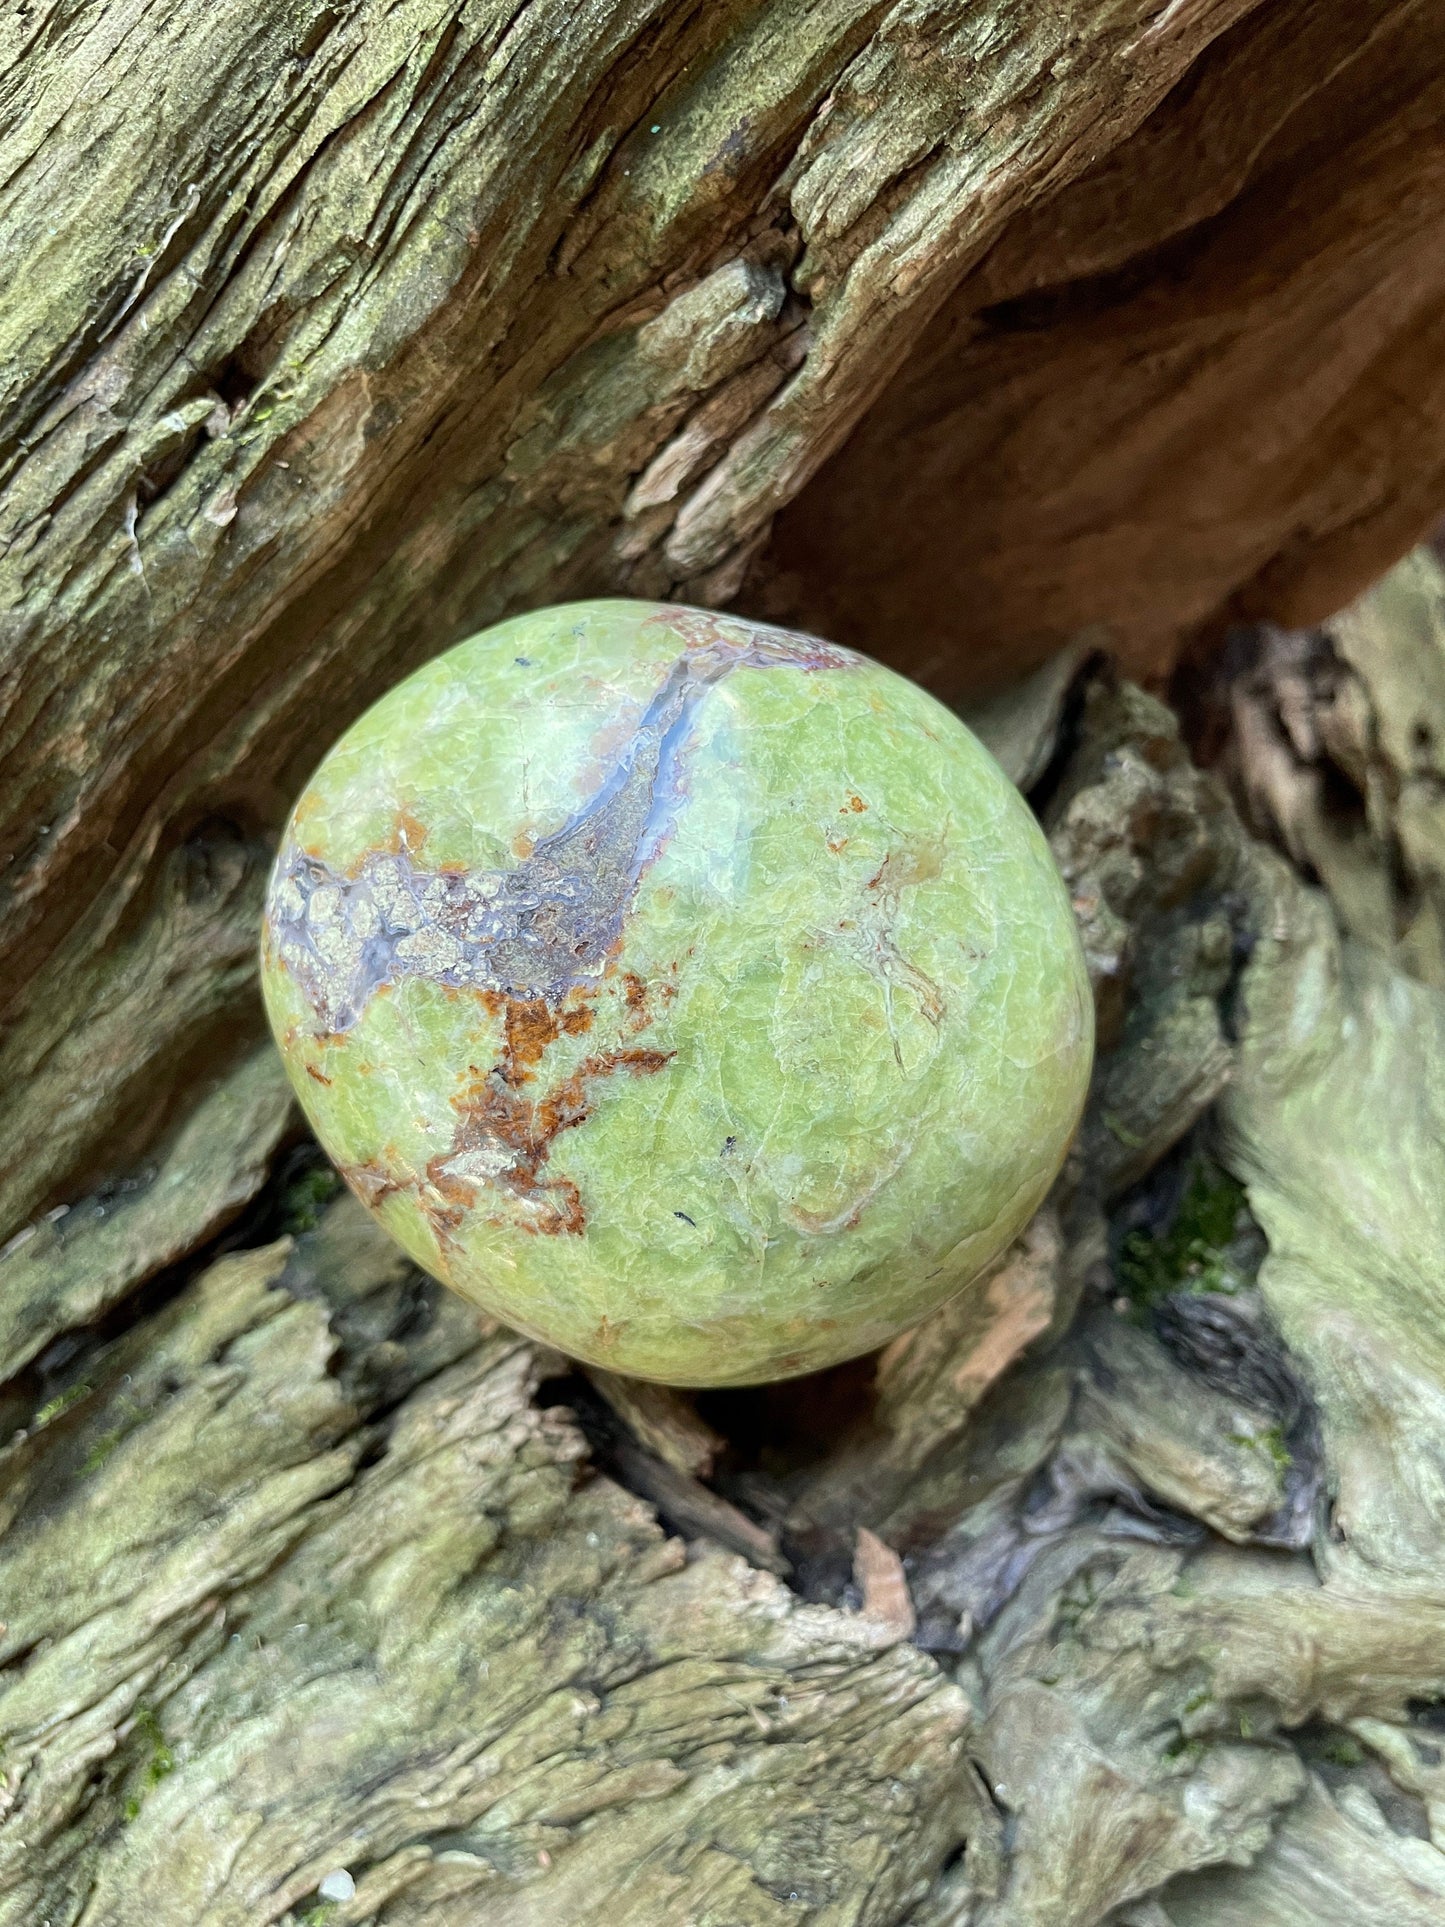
0,624,1445,1927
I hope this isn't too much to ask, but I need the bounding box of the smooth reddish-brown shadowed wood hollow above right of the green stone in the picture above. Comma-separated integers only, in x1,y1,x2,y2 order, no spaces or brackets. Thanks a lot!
771,0,1445,694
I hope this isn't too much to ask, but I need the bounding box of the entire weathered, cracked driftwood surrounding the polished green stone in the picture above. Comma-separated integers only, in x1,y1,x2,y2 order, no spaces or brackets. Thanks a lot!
0,0,1445,1927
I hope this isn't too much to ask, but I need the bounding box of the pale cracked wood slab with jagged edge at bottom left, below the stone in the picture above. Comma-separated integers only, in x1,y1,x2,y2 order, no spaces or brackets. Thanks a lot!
0,1225,977,1927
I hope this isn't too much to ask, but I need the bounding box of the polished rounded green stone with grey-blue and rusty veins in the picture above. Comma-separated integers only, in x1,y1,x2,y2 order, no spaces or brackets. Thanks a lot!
262,601,1092,1386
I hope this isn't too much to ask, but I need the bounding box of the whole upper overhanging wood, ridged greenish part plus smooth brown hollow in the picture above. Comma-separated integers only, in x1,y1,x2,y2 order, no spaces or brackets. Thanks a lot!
0,0,1445,1239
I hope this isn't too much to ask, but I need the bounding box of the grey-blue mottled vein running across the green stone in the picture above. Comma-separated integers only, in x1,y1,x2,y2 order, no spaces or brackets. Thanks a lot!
266,611,855,1040
